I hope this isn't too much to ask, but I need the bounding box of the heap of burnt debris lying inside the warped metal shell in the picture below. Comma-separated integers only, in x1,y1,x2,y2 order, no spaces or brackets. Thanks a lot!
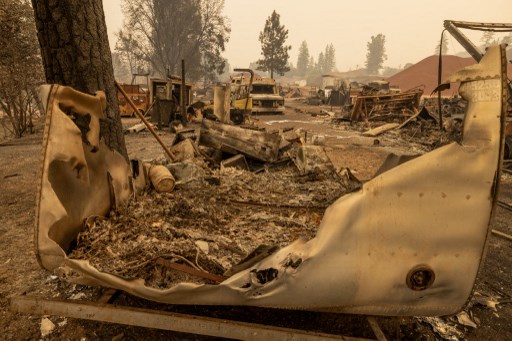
69,118,359,288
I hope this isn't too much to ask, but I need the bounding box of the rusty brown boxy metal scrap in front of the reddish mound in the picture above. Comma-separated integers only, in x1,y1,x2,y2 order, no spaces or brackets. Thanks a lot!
350,89,423,121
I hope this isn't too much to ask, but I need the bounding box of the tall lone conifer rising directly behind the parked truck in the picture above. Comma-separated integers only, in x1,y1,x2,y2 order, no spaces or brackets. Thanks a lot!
258,11,292,78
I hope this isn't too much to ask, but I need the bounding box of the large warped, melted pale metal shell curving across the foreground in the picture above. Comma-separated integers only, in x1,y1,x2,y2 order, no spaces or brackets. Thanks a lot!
36,46,506,316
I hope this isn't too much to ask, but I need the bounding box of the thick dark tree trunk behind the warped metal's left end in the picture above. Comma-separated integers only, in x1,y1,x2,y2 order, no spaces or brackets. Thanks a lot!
32,0,128,158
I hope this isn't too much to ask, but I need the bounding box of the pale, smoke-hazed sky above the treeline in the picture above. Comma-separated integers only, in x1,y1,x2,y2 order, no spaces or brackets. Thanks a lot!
103,0,512,71
